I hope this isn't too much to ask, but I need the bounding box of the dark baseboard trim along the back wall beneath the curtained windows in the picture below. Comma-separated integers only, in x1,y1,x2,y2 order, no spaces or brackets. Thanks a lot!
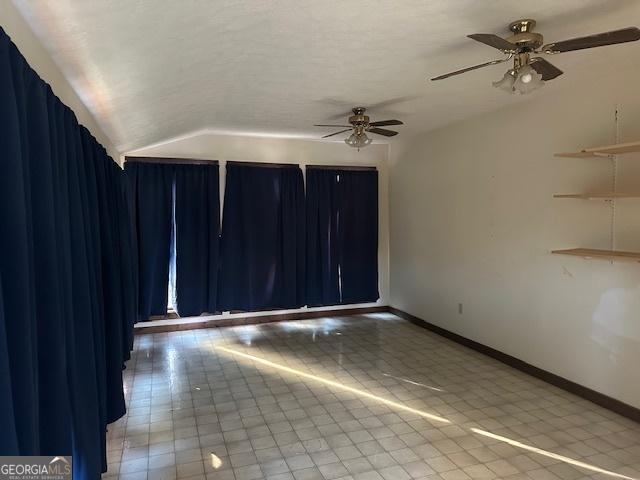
134,305,389,335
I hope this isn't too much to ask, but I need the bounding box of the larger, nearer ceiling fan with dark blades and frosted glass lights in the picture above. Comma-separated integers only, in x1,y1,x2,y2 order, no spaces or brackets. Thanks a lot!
431,19,640,94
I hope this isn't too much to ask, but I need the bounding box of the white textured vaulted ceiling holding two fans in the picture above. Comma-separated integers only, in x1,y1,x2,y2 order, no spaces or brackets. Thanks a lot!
14,0,640,152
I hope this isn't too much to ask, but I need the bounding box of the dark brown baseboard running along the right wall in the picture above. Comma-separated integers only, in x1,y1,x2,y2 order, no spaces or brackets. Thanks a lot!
388,307,640,422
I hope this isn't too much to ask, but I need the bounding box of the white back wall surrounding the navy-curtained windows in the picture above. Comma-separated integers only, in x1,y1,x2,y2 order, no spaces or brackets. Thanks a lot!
127,133,389,318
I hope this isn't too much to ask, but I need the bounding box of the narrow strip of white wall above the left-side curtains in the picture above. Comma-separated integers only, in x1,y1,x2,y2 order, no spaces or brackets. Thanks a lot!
0,0,119,161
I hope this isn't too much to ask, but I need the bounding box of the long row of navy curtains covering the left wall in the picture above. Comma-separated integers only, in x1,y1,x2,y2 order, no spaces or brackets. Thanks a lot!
0,29,135,479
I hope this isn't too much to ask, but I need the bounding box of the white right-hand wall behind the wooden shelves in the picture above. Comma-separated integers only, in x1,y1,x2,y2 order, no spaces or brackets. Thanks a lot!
389,64,640,407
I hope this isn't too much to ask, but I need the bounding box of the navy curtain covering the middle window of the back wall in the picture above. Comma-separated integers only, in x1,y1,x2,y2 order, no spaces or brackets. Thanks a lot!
218,162,305,311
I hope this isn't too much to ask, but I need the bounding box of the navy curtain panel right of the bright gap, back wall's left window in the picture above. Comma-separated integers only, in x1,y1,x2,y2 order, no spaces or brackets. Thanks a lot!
175,162,220,317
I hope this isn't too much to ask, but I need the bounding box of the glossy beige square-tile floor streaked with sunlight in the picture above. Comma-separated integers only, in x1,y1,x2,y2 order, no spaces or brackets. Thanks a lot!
105,313,640,480
